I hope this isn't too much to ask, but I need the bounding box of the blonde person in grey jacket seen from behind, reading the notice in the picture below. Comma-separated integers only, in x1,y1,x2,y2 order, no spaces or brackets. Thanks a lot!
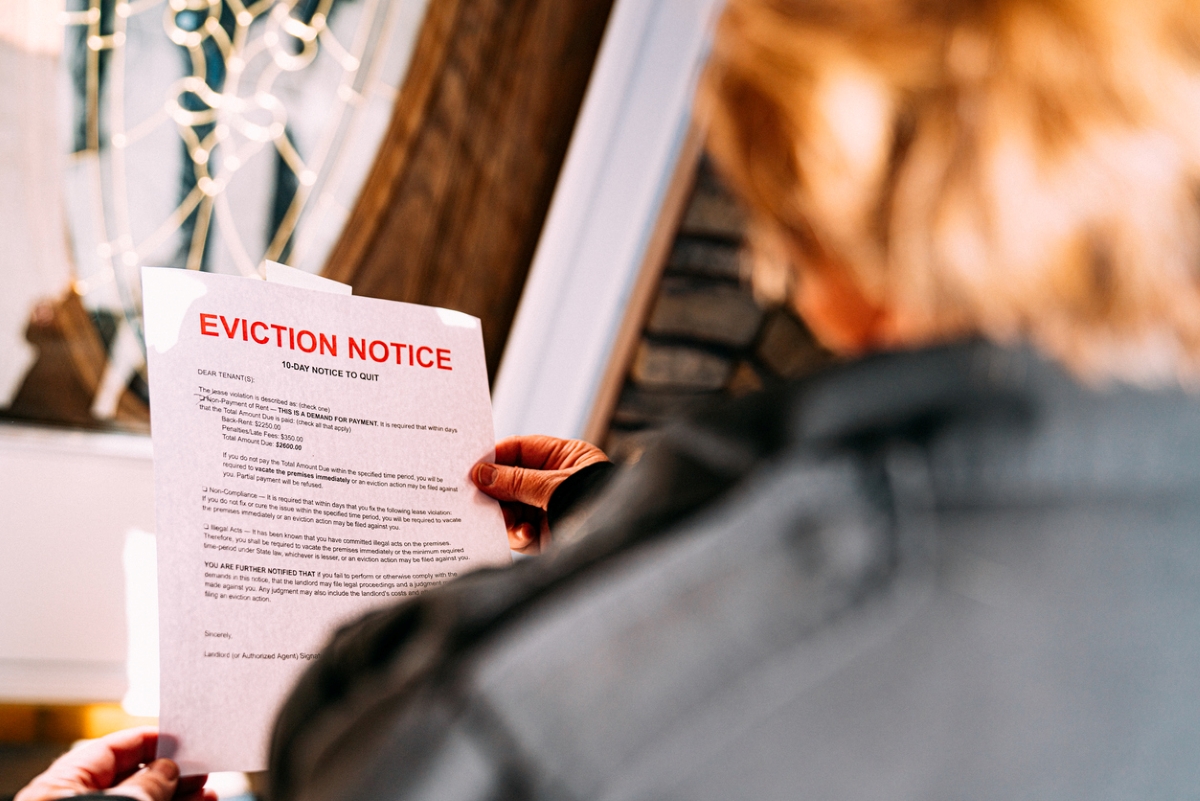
271,0,1200,801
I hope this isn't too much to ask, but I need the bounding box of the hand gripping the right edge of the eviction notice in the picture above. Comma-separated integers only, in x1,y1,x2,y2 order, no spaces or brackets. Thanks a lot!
470,436,608,554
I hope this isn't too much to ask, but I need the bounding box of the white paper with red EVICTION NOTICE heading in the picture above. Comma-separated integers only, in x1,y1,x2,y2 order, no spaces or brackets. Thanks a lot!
142,267,511,773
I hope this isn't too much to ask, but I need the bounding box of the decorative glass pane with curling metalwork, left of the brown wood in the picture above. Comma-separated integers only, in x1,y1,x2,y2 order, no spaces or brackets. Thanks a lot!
0,0,426,428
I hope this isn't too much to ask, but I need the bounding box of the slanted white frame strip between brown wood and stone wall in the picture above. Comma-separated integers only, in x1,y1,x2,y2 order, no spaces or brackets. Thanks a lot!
492,0,721,438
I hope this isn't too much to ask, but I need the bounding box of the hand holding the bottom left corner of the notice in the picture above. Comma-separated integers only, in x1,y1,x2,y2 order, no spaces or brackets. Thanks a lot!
13,727,216,801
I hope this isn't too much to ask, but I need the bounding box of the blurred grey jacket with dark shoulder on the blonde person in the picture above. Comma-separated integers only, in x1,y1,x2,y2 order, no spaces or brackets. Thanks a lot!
271,343,1200,801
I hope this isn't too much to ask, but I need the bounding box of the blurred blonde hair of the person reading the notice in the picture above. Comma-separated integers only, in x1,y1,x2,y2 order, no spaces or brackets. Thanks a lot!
697,0,1200,384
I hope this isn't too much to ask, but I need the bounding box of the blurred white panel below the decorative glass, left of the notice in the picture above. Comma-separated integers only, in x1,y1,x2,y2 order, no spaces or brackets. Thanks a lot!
0,426,155,703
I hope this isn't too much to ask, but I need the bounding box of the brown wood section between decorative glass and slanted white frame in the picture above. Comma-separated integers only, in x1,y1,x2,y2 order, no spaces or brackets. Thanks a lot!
324,0,612,375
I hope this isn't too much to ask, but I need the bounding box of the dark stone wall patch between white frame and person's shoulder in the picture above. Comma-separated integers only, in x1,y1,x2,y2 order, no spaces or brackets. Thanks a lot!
605,161,829,462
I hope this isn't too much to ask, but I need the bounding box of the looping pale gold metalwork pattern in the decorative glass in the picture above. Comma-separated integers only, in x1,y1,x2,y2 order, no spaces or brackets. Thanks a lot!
62,0,398,303
